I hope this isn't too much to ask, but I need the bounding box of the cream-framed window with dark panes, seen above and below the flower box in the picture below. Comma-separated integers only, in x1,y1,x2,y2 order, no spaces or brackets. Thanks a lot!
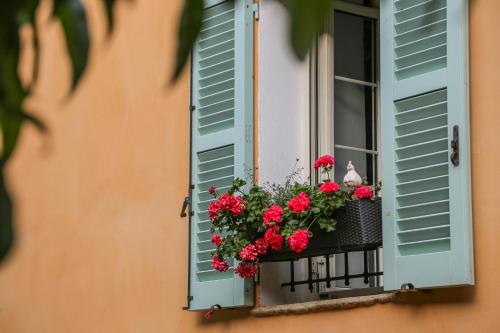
312,1,382,297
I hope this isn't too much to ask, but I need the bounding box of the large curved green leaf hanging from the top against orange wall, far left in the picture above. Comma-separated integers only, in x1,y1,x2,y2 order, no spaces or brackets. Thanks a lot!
53,0,90,91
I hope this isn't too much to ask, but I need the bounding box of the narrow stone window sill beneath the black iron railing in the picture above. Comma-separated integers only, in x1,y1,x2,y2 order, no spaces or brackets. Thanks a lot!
251,293,397,317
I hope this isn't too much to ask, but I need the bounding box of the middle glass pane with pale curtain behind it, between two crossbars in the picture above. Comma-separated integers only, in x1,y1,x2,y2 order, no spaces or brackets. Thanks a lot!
334,80,375,150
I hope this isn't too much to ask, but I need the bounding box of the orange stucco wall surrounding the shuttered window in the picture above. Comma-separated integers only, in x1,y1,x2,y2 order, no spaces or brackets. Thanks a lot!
0,0,500,333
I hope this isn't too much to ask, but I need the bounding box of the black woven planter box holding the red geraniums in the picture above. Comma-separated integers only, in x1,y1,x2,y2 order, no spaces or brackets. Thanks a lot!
259,198,382,262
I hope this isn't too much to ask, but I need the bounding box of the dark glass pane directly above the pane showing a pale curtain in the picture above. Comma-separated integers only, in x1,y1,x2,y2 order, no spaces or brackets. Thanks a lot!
333,11,375,82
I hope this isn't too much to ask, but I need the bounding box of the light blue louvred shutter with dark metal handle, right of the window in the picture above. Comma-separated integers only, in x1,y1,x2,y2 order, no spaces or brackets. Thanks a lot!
380,0,474,290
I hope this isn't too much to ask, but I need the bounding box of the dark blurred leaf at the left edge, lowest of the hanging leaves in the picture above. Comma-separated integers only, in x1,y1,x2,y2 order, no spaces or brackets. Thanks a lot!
0,164,14,261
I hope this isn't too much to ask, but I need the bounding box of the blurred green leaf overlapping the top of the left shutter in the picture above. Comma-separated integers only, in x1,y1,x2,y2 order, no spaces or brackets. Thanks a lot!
172,0,203,82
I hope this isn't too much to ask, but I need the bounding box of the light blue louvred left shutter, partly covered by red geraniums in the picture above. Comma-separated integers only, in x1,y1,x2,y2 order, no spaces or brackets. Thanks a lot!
189,0,253,310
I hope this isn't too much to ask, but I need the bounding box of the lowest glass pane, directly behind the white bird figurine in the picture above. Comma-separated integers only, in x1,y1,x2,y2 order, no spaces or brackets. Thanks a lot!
334,148,376,185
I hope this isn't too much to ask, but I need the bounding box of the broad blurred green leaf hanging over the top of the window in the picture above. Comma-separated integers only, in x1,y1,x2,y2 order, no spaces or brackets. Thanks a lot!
286,0,335,60
